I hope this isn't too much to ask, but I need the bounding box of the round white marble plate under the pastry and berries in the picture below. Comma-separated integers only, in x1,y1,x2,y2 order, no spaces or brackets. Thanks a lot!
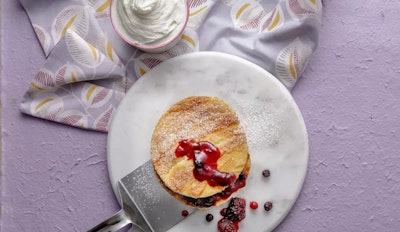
108,52,308,232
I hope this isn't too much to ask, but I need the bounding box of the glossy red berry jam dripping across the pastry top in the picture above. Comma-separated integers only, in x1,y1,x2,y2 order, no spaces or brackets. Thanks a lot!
175,140,236,187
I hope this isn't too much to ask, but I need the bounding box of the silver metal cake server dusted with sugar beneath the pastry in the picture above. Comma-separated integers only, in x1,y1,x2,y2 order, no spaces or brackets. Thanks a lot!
89,160,195,232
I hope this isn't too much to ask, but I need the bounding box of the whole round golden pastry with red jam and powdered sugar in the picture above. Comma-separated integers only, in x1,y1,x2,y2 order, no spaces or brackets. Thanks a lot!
151,96,250,206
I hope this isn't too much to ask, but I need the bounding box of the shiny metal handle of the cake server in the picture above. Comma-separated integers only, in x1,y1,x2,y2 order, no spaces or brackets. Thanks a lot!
88,210,132,232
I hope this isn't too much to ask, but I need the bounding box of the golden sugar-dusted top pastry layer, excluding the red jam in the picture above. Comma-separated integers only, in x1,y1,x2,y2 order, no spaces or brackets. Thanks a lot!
151,96,249,198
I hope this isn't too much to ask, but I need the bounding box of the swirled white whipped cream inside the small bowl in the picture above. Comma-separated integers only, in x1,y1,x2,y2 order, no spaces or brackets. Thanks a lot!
117,0,187,45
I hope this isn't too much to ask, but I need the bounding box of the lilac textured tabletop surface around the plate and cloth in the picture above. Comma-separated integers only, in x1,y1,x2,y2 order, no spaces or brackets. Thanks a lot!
1,0,400,232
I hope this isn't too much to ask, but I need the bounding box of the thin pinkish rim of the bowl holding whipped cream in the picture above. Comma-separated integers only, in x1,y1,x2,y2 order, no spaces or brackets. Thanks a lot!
110,0,190,50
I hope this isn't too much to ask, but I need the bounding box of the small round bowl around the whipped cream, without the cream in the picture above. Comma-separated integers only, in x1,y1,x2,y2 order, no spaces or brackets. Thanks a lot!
110,0,189,53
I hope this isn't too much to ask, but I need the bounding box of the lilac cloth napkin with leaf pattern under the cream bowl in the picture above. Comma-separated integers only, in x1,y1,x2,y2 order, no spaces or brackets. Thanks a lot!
20,0,321,132
